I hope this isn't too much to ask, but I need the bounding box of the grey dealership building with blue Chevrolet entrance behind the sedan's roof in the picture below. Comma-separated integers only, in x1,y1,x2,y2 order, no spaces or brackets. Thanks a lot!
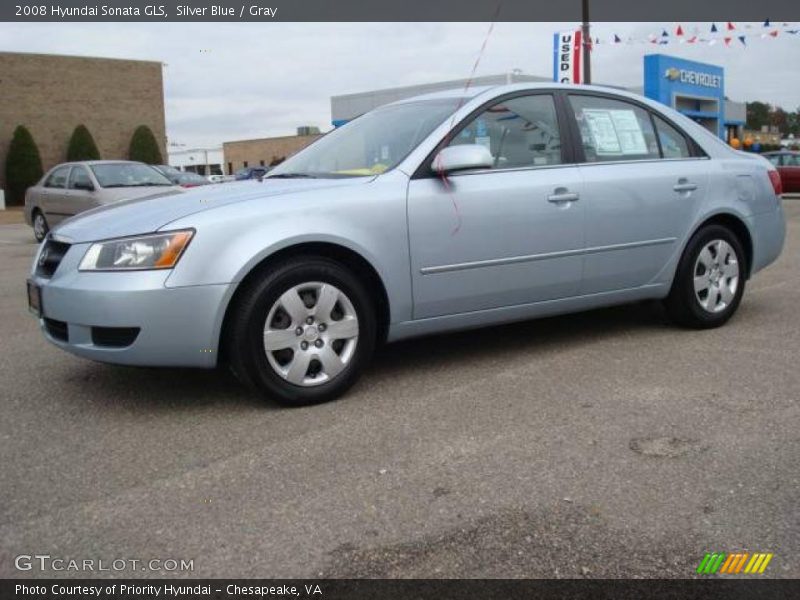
331,54,746,140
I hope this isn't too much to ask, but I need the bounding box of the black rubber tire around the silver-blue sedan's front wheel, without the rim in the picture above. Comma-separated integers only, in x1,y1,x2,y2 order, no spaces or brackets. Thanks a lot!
223,256,377,407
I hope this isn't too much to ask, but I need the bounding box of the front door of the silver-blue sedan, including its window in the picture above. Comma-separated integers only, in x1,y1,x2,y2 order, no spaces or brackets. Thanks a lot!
408,92,584,319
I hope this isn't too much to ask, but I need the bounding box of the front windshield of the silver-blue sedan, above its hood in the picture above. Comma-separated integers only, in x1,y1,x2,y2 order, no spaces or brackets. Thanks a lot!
267,98,460,179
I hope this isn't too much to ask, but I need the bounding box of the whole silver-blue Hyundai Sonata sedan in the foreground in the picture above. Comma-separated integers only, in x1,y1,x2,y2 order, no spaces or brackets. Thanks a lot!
28,84,785,405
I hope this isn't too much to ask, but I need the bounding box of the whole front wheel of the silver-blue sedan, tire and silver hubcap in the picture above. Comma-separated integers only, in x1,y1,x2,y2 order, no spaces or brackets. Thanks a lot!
226,257,377,406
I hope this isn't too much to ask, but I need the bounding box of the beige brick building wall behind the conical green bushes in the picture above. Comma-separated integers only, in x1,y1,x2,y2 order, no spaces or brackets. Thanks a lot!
0,52,167,197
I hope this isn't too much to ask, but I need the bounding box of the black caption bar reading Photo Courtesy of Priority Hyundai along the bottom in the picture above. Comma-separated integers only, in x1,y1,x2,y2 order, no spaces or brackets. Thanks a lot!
0,578,800,600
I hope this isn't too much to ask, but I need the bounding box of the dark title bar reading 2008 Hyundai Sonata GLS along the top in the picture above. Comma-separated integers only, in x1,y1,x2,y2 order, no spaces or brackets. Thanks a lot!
0,0,800,22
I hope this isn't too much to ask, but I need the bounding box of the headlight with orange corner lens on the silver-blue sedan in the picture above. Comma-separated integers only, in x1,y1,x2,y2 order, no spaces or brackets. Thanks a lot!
78,229,194,271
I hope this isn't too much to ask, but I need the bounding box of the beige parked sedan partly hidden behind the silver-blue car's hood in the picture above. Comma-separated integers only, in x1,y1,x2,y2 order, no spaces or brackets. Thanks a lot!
25,160,181,242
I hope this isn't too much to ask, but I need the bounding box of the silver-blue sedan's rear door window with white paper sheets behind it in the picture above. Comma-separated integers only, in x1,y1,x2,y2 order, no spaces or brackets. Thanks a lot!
569,95,661,162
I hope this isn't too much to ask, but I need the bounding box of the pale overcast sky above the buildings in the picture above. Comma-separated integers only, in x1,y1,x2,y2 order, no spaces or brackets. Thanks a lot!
0,22,800,148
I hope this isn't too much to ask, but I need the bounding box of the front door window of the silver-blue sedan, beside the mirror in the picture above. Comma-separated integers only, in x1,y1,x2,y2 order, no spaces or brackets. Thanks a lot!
450,94,561,169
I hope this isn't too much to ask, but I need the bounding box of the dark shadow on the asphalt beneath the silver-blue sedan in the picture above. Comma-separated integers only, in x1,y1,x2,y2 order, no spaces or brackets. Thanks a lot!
62,302,670,412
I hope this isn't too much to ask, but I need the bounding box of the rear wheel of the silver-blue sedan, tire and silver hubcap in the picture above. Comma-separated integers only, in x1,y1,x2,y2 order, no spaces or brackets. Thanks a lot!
665,225,747,329
